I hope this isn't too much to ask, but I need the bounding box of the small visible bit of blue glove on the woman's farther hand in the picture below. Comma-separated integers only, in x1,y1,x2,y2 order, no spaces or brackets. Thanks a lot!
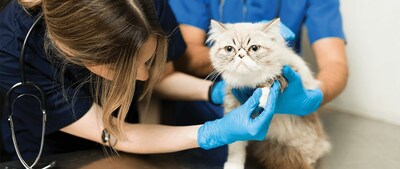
208,80,227,105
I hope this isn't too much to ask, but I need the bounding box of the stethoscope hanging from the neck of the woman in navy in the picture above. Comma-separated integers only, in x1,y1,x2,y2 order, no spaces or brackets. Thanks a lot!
5,15,56,169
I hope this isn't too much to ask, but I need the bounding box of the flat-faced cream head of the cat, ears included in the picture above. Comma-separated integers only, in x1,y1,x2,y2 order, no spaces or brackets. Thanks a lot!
207,21,287,87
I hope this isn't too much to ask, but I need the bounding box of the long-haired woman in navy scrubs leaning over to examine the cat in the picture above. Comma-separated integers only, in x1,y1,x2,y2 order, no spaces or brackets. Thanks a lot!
0,0,279,160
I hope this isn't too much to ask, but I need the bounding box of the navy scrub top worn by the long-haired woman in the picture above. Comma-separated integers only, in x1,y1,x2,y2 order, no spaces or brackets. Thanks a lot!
0,0,186,160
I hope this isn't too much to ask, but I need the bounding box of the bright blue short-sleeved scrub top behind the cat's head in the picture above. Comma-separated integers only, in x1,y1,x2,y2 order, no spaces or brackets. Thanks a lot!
169,0,344,52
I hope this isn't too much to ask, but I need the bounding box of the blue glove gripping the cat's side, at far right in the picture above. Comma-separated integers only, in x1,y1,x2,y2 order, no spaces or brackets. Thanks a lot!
276,65,324,116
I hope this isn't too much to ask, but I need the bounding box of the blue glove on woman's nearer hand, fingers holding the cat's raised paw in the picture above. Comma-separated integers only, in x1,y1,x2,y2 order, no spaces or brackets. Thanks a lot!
197,83,280,149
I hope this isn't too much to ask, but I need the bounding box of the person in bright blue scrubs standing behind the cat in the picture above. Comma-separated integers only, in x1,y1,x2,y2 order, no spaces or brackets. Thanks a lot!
169,0,348,164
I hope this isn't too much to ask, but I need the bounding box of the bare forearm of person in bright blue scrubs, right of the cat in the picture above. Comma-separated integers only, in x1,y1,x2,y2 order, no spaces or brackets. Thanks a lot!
312,38,348,104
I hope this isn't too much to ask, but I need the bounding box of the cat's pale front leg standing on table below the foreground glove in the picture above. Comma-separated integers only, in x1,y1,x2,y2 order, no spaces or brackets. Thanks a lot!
224,141,247,169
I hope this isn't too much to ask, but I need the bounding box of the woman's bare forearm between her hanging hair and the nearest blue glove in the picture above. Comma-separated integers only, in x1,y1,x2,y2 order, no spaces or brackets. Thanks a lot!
115,124,200,154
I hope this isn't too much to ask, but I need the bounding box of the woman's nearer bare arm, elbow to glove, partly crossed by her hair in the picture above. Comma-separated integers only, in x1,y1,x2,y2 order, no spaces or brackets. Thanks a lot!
61,104,200,153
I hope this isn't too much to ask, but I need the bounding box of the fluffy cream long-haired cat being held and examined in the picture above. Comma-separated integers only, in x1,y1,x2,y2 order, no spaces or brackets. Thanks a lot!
207,19,330,169
